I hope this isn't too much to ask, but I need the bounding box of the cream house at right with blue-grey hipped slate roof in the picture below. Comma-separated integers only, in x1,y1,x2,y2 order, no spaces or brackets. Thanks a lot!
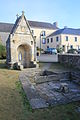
45,27,80,52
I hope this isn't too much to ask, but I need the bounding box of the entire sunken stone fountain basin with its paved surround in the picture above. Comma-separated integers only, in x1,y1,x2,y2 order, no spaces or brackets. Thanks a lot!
19,69,80,109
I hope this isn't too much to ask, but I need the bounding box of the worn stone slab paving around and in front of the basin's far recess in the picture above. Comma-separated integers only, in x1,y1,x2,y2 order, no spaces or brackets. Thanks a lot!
19,68,80,109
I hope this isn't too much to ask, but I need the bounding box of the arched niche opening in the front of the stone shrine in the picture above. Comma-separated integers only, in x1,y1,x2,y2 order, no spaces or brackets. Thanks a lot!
17,44,31,68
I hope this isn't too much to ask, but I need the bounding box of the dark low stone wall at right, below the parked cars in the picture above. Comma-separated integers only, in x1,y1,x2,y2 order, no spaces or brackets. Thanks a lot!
58,54,80,69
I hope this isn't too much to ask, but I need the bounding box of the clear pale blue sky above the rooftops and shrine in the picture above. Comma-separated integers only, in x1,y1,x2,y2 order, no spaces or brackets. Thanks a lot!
0,0,80,28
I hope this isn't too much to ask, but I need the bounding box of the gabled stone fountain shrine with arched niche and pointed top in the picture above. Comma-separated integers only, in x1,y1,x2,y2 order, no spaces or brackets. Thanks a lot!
6,13,36,68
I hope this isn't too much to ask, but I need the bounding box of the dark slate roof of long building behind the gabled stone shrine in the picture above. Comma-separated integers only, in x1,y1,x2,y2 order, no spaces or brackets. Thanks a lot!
0,17,58,33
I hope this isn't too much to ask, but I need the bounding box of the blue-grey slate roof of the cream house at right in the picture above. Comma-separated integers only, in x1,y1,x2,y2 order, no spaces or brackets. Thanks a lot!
48,28,80,37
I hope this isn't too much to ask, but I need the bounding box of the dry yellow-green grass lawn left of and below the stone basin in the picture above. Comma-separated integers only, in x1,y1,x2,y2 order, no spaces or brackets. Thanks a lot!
0,61,80,120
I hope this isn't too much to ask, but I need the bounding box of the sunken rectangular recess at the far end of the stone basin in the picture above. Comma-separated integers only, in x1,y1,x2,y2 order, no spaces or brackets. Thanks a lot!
34,71,70,84
